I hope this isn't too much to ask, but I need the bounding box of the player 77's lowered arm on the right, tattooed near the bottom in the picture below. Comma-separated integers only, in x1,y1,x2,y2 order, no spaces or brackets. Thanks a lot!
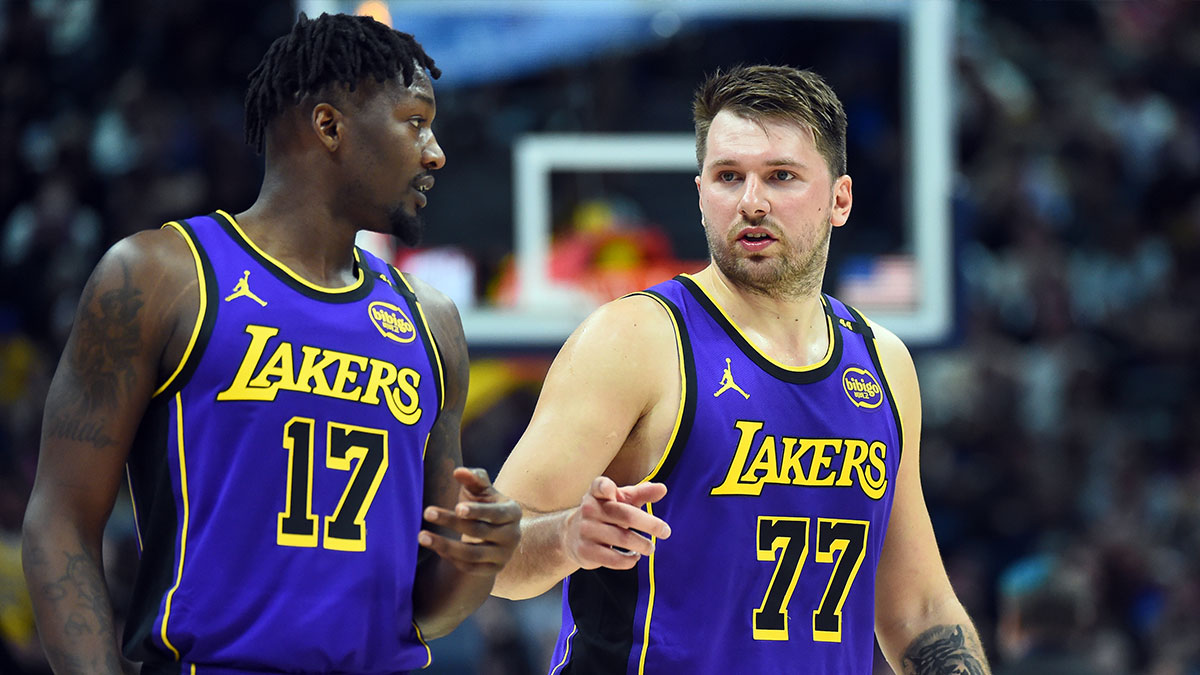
875,325,990,675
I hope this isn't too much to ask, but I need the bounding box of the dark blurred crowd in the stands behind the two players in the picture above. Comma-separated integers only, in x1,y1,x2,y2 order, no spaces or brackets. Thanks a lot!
0,0,1200,675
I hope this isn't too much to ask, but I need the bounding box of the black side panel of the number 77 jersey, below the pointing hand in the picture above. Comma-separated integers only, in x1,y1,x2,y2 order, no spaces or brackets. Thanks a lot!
559,567,638,675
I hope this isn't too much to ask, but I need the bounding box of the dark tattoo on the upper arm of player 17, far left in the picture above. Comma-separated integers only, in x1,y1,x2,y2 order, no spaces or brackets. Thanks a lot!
72,260,145,412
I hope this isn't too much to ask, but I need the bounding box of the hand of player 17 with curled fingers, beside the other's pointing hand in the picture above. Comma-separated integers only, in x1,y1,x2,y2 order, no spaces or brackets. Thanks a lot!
416,466,521,575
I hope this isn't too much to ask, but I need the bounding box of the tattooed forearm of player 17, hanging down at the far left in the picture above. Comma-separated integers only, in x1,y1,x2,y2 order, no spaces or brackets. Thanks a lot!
22,514,122,675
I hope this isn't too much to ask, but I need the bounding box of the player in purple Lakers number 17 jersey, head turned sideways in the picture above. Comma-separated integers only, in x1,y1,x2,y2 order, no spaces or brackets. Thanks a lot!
24,14,521,674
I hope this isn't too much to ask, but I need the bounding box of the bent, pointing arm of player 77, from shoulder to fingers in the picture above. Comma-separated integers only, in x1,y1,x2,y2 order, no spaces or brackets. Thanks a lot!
493,295,680,599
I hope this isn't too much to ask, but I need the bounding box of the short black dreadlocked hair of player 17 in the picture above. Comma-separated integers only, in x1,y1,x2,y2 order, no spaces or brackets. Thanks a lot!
246,12,442,153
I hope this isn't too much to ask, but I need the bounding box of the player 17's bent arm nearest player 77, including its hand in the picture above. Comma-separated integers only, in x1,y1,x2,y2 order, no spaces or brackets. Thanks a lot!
409,277,521,639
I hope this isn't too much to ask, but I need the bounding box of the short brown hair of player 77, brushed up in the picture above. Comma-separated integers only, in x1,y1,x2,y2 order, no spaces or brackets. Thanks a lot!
691,66,846,178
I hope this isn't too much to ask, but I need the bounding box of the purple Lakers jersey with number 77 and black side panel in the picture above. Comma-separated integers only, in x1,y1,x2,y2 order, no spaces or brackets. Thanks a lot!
551,275,901,675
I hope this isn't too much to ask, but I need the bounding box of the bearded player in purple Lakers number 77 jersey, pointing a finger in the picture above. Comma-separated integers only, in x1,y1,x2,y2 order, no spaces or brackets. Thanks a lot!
493,66,988,675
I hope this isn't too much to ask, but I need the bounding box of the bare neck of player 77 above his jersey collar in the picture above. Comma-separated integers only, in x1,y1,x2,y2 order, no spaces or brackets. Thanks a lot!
692,264,829,368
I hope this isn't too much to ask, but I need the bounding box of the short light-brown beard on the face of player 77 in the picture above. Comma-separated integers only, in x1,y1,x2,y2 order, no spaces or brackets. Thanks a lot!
704,217,833,299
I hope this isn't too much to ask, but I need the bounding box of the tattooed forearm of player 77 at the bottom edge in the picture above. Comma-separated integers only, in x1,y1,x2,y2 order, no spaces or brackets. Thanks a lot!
880,599,991,675
